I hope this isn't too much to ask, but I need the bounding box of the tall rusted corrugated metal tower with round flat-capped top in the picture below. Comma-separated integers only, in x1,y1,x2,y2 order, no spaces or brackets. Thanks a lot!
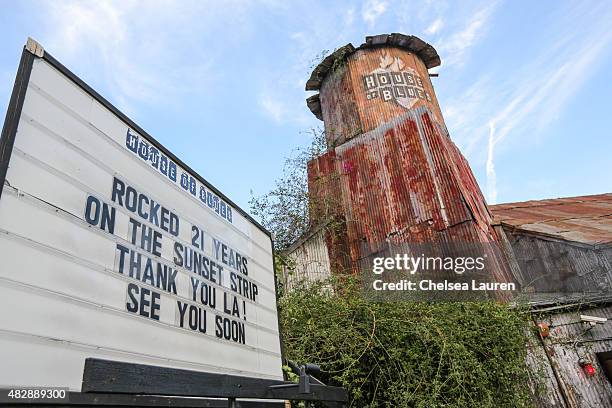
306,34,511,281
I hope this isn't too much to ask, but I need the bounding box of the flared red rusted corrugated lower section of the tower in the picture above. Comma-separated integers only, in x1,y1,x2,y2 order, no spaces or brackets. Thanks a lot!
308,106,511,281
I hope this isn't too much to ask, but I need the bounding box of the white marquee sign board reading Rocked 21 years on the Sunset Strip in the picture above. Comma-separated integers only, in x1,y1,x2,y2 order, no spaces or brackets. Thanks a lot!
0,43,282,391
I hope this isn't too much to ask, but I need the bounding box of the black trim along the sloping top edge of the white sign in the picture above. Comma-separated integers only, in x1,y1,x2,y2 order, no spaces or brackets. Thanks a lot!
37,51,272,240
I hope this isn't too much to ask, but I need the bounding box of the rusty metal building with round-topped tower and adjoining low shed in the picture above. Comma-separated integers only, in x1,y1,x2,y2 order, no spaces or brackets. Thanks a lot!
284,34,612,408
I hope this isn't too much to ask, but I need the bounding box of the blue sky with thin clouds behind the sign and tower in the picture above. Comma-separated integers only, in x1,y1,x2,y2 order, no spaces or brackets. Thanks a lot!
0,0,612,215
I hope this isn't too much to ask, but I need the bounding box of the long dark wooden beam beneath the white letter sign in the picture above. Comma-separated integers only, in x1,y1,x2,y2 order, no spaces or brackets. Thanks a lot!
82,358,348,402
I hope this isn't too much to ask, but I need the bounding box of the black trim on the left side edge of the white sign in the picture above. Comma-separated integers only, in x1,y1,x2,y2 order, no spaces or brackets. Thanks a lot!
0,47,36,198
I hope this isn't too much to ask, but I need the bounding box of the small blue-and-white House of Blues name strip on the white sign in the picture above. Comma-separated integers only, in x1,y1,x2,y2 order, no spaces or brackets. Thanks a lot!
125,129,232,222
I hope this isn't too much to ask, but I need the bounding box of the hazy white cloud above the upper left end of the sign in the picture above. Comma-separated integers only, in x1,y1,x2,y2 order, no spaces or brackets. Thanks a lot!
39,0,239,113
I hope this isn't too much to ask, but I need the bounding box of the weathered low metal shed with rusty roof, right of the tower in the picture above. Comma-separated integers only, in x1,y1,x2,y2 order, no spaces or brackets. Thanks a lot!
498,198,612,408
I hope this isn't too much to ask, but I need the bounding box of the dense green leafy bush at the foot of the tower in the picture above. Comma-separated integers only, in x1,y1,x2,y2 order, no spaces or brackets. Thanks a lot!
280,282,531,408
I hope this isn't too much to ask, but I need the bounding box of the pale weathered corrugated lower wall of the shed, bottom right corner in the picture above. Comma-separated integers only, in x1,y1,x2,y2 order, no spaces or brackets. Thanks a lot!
531,306,612,408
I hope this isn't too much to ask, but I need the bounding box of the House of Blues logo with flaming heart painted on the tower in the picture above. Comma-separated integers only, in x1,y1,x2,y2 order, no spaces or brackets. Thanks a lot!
363,53,431,109
